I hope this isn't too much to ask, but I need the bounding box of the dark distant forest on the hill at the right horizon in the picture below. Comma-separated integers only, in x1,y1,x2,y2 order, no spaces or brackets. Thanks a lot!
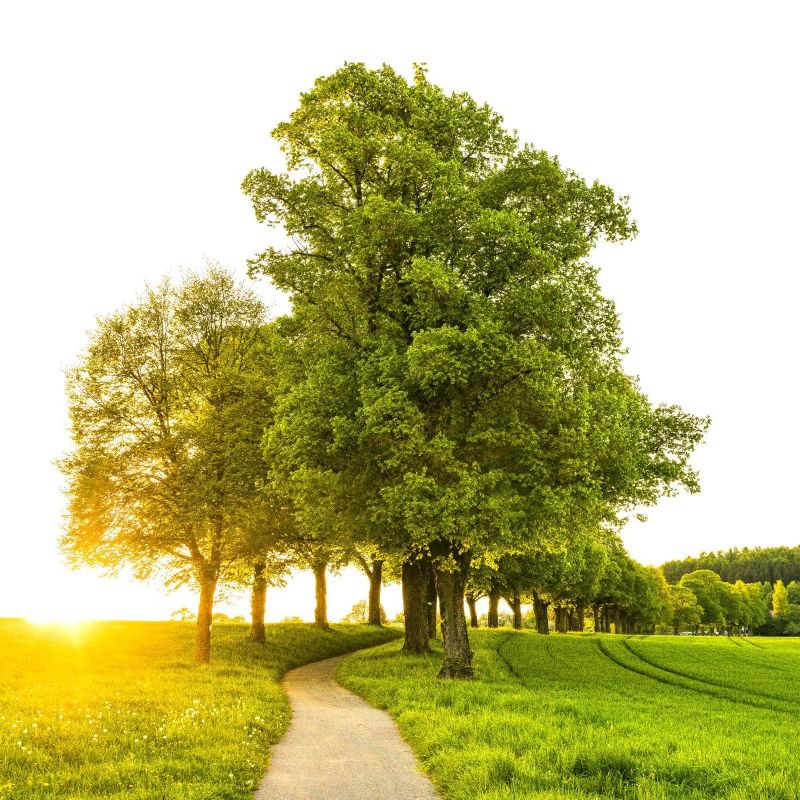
661,546,800,584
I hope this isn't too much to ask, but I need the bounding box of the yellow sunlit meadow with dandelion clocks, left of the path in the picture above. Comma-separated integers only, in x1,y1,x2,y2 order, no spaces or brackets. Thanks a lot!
0,620,399,800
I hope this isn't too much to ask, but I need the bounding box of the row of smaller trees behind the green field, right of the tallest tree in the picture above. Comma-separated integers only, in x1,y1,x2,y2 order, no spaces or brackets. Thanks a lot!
466,564,800,635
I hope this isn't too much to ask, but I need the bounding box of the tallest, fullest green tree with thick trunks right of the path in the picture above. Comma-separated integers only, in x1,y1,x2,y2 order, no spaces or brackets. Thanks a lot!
243,64,705,677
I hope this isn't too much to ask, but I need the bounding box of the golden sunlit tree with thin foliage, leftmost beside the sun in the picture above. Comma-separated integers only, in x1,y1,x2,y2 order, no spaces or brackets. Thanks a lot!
61,267,269,662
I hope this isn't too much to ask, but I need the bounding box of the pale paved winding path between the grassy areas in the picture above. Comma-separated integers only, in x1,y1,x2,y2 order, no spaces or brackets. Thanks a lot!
255,656,439,800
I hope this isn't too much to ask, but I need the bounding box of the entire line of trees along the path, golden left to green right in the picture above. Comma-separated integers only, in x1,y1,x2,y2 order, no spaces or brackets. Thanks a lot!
61,64,708,678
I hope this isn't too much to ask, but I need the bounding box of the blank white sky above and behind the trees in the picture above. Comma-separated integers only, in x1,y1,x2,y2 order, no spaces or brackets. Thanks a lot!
0,0,800,619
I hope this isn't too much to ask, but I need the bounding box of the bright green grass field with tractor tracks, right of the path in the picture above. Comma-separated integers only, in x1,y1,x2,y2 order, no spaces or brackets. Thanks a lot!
339,630,800,800
